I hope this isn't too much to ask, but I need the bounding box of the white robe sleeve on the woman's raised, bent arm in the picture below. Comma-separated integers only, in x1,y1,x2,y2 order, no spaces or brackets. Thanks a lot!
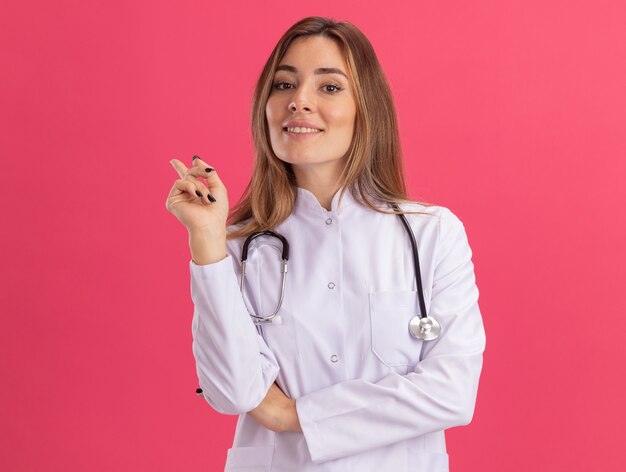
189,247,279,415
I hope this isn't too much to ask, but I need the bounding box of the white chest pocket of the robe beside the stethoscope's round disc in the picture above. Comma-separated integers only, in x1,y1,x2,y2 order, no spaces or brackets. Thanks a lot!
370,291,423,367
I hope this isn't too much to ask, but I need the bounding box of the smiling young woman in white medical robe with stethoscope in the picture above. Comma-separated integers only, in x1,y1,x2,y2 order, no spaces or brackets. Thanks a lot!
167,17,485,472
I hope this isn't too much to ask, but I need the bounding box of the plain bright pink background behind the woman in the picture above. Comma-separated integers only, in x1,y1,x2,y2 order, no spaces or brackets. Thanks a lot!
0,0,626,472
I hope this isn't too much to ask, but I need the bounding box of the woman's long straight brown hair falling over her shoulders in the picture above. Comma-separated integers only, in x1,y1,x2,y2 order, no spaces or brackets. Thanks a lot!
228,16,428,239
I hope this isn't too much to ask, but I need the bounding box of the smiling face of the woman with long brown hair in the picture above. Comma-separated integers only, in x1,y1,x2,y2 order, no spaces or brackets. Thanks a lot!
265,36,356,182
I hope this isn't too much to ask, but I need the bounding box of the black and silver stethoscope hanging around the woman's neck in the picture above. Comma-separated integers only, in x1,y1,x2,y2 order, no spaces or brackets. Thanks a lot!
196,204,441,396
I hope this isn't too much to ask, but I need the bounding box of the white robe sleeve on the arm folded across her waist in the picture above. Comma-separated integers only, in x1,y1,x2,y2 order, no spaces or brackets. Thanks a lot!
296,209,485,463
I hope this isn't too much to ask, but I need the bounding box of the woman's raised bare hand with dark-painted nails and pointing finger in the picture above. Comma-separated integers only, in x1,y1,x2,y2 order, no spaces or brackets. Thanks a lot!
165,156,228,234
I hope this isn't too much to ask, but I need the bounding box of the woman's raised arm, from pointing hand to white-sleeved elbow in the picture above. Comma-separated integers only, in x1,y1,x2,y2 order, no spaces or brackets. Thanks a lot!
165,156,278,414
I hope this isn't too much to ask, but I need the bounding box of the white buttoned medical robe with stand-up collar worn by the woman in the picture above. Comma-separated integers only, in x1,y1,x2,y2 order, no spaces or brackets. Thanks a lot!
190,188,485,472
